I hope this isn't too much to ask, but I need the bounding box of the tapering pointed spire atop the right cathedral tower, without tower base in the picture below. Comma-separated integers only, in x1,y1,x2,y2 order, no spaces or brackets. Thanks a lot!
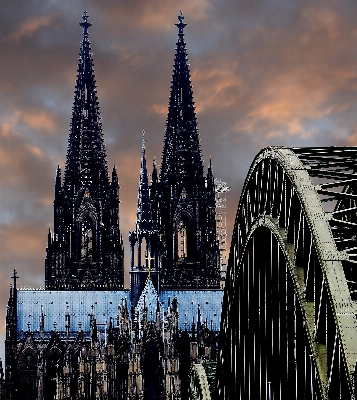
161,12,203,186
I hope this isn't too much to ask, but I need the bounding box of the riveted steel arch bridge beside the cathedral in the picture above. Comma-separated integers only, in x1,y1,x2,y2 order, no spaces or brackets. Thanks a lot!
217,147,357,400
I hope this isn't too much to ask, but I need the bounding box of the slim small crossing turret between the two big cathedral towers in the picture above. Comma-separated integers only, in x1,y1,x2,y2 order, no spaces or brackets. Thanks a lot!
129,131,160,307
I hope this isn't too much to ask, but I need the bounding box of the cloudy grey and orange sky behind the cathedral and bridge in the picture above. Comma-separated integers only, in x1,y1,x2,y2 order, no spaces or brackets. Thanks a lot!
0,0,357,358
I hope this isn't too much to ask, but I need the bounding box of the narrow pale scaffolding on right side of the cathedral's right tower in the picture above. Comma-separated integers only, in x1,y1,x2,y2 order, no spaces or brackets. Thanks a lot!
214,178,231,281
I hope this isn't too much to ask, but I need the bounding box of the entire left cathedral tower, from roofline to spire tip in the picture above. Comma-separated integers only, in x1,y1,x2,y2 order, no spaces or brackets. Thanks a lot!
45,12,124,290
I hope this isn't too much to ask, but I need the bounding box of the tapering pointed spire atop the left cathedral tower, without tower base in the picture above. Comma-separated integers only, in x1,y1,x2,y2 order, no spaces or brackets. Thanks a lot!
64,11,109,195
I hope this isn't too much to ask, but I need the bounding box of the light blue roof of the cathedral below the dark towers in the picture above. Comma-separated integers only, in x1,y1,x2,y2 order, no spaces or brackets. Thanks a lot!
17,288,223,333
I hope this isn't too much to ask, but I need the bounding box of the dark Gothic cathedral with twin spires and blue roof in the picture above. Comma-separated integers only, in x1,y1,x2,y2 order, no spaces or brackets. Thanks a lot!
0,12,223,400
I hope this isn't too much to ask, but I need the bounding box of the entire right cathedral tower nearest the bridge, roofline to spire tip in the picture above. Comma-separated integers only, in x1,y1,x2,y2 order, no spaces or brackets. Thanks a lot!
153,13,220,289
